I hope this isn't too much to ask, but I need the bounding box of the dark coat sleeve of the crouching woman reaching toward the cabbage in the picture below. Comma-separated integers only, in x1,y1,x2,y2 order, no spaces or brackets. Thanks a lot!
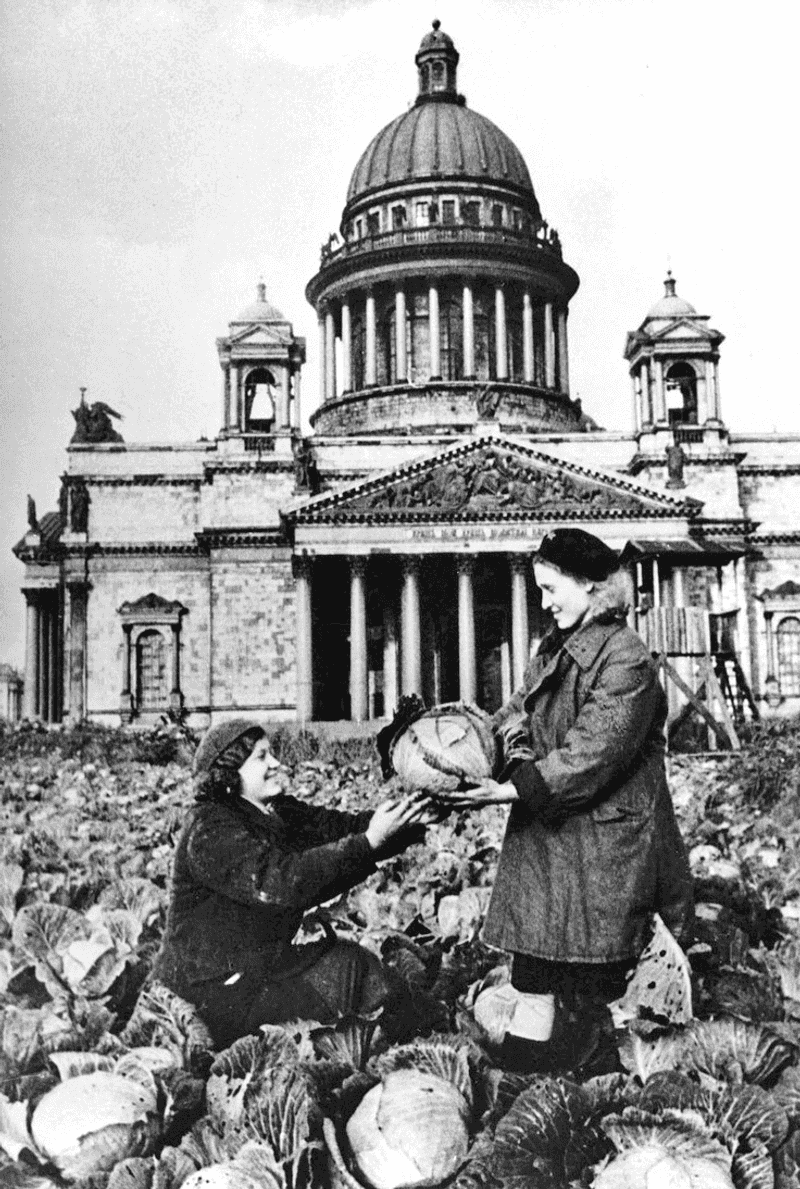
185,806,376,912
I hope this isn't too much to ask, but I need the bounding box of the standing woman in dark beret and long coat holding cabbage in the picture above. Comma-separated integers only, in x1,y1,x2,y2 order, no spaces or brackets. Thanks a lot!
456,529,692,1071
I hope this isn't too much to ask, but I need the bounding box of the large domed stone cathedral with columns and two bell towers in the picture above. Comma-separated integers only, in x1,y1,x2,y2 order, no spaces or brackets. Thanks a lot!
15,21,800,726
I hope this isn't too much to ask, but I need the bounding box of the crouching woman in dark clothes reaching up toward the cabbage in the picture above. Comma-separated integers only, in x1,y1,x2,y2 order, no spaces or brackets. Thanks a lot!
155,719,426,1046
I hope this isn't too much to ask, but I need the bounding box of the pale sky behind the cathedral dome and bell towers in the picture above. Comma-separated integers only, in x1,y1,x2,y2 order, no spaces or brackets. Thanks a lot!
0,0,800,663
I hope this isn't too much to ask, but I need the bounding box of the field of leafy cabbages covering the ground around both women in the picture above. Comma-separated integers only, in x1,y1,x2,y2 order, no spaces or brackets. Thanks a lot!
0,722,800,1189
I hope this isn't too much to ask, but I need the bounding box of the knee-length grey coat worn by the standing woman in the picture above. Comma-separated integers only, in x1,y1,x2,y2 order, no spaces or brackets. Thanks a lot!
484,619,692,962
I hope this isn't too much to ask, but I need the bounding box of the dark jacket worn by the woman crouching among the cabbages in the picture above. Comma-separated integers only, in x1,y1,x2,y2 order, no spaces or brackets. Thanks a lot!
155,797,376,1002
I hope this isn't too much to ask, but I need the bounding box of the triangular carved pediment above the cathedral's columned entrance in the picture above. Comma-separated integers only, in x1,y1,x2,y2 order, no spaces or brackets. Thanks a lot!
288,438,701,524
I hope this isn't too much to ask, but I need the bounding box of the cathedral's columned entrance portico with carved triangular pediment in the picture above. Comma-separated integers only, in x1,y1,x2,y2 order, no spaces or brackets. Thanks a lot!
290,438,694,722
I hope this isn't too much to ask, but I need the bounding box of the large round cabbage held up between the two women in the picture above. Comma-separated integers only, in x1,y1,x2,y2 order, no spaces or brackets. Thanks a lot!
389,702,499,797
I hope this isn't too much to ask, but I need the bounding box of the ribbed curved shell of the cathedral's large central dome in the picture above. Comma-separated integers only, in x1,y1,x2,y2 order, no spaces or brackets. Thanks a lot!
347,102,534,205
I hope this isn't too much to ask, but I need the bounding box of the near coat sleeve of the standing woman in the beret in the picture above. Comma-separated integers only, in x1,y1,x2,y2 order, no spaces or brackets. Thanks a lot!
510,647,661,822
